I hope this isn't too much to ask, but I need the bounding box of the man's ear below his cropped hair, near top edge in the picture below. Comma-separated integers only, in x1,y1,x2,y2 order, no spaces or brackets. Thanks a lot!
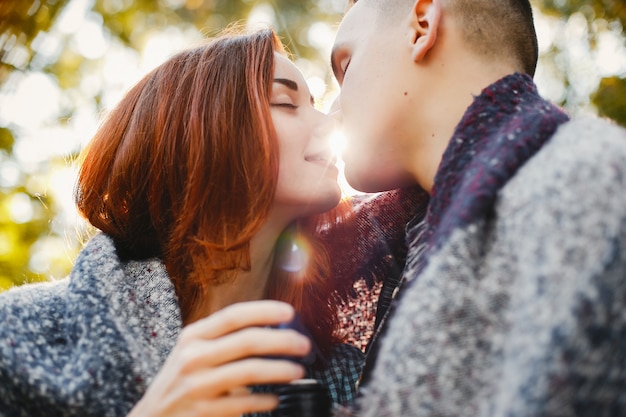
409,0,441,62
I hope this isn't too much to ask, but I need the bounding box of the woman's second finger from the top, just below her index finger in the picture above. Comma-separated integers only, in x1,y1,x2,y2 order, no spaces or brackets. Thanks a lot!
179,327,311,373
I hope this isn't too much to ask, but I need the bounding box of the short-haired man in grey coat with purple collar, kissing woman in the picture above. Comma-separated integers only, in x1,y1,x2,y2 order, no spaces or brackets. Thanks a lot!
332,0,626,417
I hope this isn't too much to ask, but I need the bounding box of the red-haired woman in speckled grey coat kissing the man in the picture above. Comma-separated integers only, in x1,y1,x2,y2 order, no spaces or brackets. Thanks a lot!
0,30,361,416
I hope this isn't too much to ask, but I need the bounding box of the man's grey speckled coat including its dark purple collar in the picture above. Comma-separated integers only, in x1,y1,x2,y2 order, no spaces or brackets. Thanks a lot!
336,74,626,417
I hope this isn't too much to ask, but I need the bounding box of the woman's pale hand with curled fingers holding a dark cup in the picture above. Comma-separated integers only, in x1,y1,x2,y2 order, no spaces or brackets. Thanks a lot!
129,301,310,417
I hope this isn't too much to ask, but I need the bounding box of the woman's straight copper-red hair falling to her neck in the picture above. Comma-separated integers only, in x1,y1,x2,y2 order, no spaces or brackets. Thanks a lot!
76,29,348,358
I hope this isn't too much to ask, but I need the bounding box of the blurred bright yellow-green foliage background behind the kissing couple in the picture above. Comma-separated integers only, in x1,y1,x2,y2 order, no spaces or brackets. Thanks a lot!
0,0,626,291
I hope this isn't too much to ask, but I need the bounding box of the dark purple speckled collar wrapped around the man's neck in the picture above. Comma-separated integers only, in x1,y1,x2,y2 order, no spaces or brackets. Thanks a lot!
414,73,569,267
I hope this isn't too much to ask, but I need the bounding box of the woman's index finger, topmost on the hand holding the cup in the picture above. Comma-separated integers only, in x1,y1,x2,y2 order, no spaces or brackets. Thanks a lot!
181,300,295,340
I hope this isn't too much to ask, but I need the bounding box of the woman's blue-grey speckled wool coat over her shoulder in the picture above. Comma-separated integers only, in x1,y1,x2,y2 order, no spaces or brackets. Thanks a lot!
0,234,362,417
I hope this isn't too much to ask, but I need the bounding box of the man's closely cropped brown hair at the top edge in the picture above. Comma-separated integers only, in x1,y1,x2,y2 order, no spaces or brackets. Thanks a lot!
368,0,539,76
